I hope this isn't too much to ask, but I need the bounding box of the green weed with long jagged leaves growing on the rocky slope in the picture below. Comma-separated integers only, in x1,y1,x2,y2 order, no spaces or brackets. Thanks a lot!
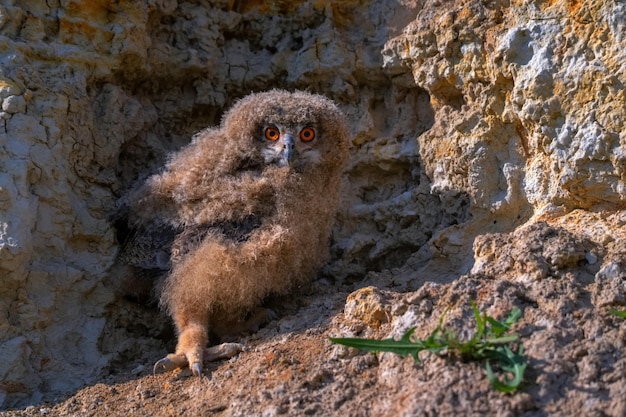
330,301,526,392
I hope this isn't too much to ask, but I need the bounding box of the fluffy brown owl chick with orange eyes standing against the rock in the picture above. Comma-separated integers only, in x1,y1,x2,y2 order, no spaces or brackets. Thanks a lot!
120,90,348,376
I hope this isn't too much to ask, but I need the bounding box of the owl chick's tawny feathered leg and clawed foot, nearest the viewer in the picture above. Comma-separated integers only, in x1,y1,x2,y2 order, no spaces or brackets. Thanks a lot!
153,312,208,376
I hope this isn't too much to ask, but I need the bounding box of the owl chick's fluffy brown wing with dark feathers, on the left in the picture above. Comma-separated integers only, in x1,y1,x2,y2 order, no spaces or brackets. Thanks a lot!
114,136,272,271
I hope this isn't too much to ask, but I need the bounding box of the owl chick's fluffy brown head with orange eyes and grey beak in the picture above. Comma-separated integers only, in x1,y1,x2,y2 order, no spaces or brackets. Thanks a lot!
222,90,348,171
